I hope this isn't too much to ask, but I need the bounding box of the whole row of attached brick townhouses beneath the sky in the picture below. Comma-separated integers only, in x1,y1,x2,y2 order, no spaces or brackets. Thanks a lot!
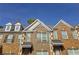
0,19,79,55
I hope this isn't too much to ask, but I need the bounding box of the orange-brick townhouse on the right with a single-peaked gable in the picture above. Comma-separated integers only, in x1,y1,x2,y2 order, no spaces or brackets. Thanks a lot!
52,20,79,55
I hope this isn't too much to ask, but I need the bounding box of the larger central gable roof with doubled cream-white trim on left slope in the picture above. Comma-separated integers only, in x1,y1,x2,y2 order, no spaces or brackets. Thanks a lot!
23,19,51,31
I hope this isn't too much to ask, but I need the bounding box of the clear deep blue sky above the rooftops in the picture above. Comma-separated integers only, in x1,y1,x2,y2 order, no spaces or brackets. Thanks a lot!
0,3,79,26
